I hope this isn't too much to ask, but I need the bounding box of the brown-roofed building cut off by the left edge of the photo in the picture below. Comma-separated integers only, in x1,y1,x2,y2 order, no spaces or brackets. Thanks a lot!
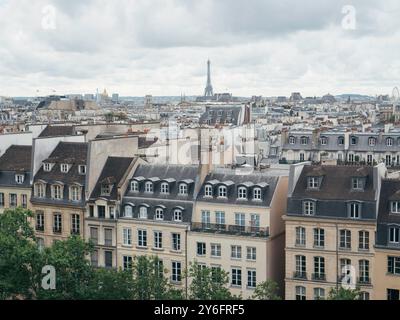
0,145,32,213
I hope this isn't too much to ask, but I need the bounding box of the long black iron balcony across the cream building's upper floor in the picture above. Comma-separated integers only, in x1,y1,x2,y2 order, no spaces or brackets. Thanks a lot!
191,222,269,237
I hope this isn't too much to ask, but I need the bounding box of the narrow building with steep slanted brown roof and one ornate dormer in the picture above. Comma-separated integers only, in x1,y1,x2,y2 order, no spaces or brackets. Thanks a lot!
84,157,139,268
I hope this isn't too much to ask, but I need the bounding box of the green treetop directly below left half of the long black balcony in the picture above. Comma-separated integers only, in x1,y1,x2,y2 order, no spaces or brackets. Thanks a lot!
186,261,237,300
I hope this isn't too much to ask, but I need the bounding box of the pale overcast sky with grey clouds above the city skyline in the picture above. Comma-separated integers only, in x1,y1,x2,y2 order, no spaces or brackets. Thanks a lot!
0,0,400,96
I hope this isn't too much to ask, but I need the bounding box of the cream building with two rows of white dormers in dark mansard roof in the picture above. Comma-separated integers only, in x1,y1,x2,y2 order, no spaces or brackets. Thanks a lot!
117,164,198,286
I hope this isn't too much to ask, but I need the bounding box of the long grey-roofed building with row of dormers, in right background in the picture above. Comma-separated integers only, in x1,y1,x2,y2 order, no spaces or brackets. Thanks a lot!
281,130,400,167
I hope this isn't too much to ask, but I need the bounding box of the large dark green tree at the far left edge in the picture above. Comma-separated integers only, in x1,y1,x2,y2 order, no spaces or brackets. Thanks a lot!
0,208,41,299
